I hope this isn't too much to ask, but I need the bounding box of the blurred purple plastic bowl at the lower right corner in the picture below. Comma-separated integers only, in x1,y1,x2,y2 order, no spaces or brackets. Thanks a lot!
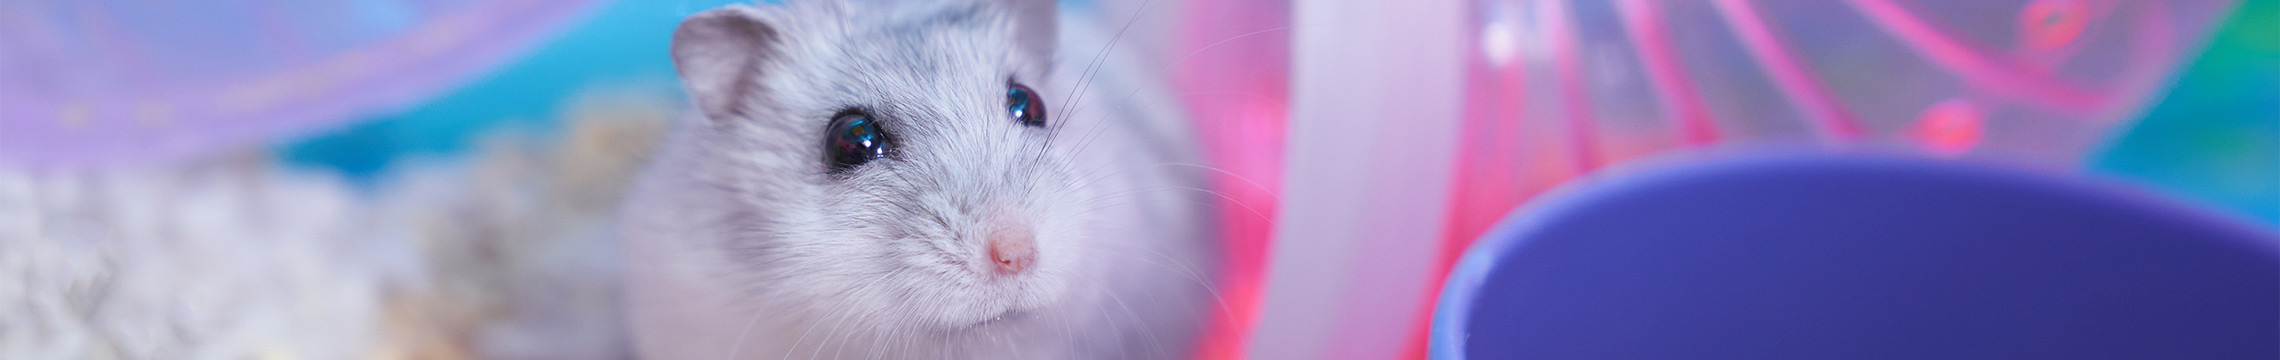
1430,155,2280,360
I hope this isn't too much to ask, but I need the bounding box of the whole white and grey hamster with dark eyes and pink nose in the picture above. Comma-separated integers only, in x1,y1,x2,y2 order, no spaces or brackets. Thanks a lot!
620,0,1224,360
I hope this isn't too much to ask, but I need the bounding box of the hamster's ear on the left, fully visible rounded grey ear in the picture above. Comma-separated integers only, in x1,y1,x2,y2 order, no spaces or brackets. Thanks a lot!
673,5,780,118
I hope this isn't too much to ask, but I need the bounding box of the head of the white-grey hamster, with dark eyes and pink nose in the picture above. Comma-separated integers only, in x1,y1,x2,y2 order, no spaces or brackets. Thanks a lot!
673,0,1092,333
